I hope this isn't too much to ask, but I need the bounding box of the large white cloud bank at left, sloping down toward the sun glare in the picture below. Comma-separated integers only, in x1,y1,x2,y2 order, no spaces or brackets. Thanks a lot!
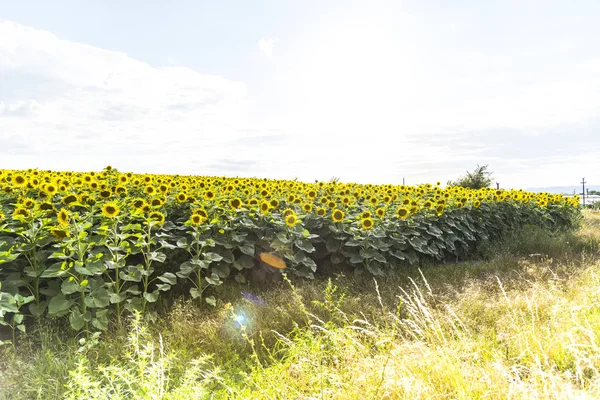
0,21,253,172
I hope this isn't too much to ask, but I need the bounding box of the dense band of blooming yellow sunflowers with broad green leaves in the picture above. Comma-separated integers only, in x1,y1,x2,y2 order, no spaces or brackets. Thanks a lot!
0,167,579,332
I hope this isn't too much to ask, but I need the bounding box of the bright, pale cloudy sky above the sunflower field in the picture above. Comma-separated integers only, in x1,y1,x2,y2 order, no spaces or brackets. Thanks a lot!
0,0,600,188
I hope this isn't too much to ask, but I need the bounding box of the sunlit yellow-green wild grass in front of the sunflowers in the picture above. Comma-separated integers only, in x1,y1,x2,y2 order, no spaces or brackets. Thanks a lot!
0,212,600,399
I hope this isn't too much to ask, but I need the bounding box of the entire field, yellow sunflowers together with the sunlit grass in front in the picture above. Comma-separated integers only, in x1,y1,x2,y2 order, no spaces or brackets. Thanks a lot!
0,168,600,399
